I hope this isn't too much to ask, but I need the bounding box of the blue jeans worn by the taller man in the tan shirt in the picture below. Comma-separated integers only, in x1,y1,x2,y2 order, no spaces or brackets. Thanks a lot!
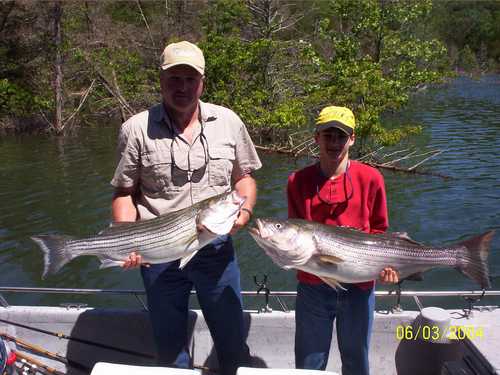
141,236,249,375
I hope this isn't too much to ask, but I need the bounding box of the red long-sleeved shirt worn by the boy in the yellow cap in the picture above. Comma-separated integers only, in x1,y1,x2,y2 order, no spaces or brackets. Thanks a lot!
287,160,389,289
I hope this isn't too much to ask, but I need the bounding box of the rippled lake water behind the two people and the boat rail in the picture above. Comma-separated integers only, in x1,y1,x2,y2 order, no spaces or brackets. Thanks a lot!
0,76,500,307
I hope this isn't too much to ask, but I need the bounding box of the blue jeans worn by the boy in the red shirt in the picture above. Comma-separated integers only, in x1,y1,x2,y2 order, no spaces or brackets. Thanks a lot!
295,283,375,375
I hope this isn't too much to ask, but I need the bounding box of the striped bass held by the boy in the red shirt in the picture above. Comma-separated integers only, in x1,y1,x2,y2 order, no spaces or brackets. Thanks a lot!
250,219,494,288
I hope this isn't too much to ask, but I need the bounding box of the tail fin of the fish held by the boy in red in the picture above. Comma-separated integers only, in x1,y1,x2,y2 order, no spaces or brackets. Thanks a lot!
457,230,495,289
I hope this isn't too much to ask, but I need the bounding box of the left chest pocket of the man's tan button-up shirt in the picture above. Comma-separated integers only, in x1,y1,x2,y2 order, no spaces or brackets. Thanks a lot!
140,150,178,198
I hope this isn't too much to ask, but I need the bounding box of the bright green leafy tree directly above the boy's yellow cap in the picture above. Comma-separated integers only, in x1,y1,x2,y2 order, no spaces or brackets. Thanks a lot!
300,0,447,153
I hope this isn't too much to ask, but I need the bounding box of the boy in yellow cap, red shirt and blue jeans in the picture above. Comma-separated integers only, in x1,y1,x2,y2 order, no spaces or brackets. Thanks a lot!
287,106,398,375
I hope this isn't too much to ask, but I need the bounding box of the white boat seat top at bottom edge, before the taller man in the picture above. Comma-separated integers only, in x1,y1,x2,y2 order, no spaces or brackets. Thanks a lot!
90,362,200,375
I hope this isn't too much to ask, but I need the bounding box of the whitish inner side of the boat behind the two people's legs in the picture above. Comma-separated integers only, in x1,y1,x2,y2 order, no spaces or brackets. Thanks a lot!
0,306,500,375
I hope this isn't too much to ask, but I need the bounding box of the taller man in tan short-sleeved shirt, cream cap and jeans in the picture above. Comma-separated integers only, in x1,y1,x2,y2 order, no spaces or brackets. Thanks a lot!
111,41,261,375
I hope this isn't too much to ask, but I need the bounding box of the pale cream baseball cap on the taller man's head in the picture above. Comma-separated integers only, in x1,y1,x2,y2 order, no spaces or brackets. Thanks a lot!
160,41,205,75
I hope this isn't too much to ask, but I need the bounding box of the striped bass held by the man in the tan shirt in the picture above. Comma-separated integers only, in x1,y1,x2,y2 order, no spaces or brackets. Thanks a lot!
31,191,245,278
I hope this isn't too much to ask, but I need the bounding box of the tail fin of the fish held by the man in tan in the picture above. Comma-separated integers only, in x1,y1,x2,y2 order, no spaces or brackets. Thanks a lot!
31,234,74,279
